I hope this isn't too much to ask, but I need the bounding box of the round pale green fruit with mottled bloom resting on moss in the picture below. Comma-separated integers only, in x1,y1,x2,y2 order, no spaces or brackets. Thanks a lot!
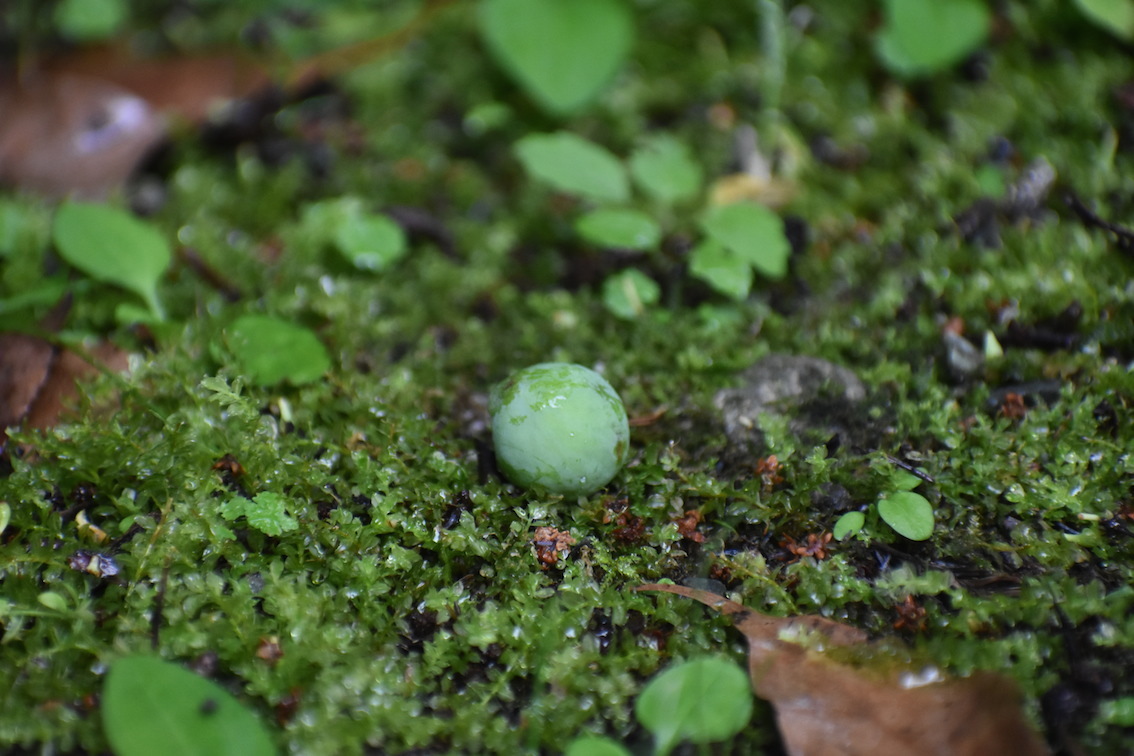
489,363,631,495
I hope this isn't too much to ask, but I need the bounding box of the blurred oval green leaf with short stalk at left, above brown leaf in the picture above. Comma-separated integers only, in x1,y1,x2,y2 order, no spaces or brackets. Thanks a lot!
52,202,172,317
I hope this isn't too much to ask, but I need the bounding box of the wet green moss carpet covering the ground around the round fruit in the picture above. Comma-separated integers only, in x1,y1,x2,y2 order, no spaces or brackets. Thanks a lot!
0,1,1134,754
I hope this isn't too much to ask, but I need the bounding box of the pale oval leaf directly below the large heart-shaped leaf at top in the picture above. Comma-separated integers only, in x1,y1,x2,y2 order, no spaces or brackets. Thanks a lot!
516,131,629,202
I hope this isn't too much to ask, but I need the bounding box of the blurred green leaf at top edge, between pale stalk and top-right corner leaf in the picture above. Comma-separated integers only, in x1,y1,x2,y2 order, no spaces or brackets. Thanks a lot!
875,0,992,76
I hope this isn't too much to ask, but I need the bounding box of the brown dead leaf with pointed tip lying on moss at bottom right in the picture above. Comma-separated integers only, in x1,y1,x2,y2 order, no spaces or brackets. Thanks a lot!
637,584,1050,756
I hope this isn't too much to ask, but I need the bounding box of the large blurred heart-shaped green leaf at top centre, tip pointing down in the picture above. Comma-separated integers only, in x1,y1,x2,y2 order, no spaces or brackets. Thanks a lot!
480,0,634,116
